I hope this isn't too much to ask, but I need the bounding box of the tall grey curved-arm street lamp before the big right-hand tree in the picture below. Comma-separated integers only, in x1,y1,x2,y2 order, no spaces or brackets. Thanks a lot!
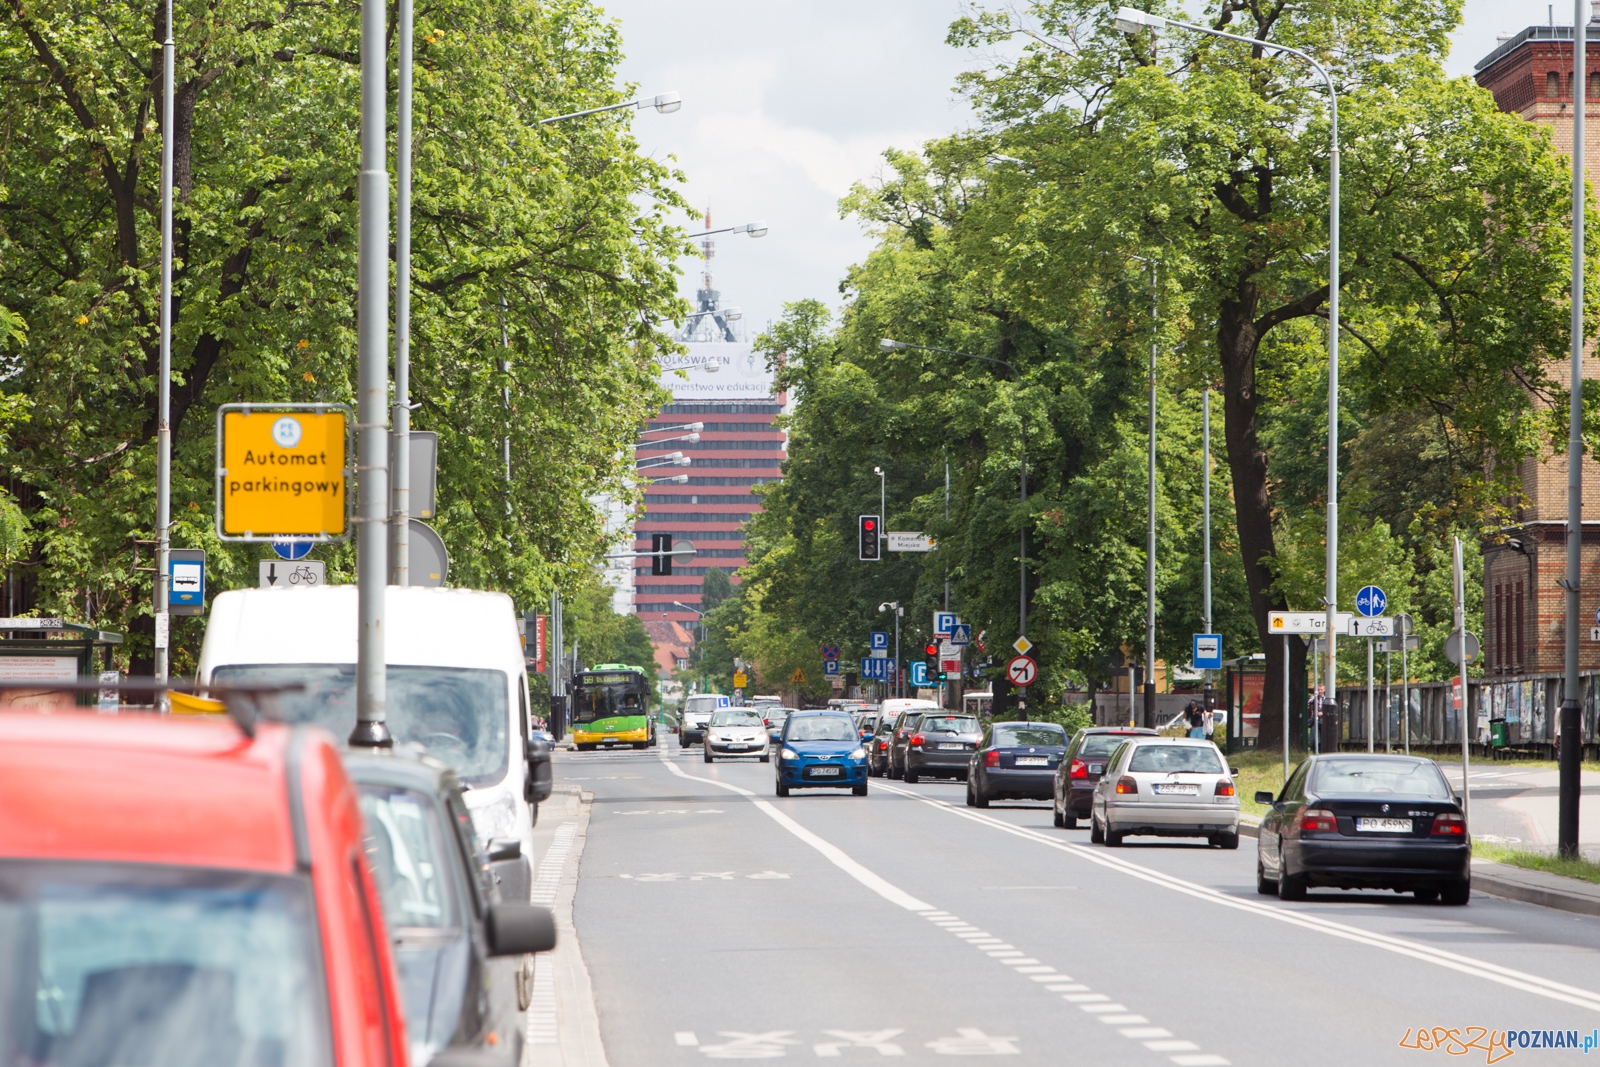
1115,0,1337,734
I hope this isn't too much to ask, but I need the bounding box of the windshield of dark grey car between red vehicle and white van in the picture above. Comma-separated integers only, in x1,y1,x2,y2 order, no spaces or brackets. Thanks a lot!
360,784,456,929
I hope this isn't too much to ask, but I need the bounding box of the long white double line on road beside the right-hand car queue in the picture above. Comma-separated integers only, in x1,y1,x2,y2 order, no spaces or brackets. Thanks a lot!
878,784,1600,1011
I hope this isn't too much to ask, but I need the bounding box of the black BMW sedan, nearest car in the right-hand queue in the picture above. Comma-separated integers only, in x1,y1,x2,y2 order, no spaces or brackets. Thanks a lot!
1256,753,1472,904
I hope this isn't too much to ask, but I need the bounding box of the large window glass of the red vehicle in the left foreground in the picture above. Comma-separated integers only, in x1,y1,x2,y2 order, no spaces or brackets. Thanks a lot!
0,861,333,1067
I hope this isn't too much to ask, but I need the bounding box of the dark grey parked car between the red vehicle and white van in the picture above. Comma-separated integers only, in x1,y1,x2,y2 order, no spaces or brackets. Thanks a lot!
344,745,555,1067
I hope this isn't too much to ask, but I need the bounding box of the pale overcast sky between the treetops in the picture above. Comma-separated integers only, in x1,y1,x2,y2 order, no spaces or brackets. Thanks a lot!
602,0,1542,338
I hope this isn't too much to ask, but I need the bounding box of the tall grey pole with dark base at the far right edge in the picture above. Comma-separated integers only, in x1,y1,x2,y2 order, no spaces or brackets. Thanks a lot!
1561,0,1589,859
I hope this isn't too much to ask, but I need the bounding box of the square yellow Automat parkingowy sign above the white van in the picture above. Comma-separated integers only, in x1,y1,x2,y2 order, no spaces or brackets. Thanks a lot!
216,405,350,541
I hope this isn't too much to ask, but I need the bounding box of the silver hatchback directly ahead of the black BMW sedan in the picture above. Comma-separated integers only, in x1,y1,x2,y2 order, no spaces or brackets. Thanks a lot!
1090,736,1238,848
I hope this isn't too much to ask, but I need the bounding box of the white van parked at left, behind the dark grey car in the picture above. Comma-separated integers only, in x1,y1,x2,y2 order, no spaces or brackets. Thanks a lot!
197,585,536,862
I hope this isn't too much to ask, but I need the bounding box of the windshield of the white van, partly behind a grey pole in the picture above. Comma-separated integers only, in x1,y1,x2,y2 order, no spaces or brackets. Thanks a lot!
211,664,510,785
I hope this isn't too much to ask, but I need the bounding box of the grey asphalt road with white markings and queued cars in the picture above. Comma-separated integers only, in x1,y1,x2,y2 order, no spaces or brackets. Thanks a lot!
557,744,1600,1067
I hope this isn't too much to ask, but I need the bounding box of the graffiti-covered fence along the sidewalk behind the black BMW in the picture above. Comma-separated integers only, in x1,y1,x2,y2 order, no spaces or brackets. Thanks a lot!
1339,675,1600,758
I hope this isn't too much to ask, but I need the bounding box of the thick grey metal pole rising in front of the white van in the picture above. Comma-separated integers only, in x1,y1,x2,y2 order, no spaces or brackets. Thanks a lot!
350,0,394,747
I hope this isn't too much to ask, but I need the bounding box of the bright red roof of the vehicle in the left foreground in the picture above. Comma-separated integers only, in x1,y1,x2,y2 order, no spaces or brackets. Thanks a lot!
0,712,300,873
